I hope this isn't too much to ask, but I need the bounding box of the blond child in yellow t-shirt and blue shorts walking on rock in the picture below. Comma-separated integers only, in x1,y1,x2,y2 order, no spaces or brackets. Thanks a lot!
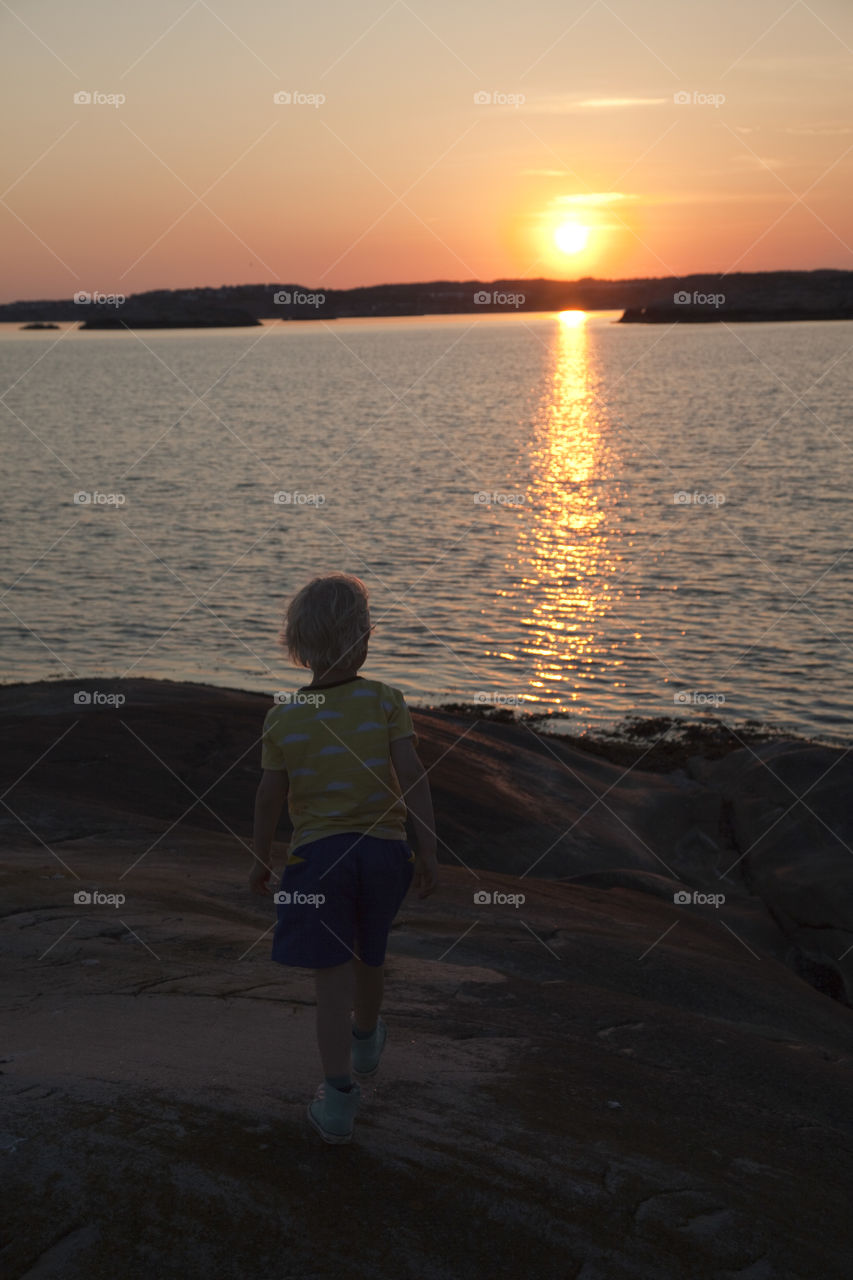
248,573,438,1143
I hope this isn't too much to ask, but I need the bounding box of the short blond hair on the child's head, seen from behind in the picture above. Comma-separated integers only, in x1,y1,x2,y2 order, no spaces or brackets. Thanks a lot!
279,573,373,675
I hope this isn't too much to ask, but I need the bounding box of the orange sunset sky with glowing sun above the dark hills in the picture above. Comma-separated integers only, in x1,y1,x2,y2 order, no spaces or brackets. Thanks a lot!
0,0,853,302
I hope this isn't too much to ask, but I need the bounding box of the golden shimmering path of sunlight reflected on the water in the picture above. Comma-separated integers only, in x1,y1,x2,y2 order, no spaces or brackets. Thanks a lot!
507,311,624,710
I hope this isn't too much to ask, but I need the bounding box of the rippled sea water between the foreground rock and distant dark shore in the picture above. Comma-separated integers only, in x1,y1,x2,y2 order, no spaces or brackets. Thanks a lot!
0,312,853,742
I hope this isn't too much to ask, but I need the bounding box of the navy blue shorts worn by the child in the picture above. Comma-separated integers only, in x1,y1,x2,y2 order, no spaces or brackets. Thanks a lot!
273,831,415,969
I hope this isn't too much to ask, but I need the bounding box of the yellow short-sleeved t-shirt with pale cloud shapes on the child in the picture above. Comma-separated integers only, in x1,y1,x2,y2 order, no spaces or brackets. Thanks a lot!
261,676,418,860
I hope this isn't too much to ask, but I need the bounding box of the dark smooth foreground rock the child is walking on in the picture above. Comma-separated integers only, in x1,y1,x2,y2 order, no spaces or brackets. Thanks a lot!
0,681,853,1280
